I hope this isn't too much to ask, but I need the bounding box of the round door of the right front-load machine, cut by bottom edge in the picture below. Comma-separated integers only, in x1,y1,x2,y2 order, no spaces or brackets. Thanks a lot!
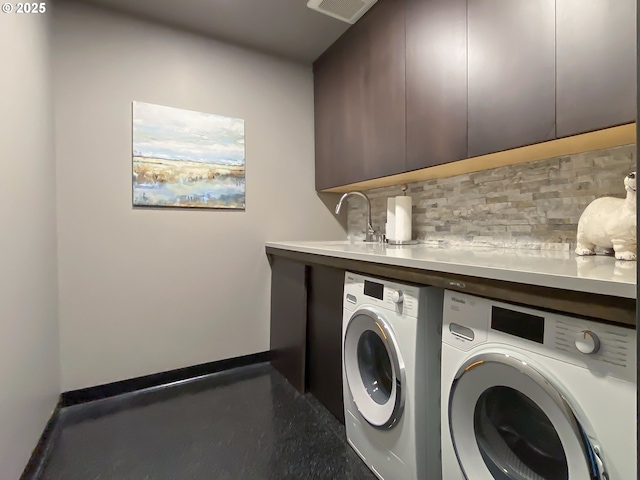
449,353,605,480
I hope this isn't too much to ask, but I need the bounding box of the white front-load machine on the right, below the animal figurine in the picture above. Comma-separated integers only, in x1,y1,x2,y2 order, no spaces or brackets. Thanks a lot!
441,291,637,480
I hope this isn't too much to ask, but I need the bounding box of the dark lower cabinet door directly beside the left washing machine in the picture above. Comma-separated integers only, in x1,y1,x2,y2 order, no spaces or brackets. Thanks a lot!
307,265,344,423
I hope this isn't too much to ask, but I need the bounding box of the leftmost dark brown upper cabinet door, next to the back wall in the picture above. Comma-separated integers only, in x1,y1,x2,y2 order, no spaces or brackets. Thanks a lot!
313,0,406,190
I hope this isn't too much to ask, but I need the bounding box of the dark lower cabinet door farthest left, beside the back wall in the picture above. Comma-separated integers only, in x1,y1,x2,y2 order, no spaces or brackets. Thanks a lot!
270,256,307,393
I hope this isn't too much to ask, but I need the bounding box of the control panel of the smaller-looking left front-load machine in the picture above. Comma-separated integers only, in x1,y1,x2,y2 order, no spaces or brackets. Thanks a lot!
343,272,420,318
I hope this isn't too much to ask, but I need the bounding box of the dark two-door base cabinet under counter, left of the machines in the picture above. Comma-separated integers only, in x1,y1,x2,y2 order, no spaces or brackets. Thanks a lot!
270,255,344,423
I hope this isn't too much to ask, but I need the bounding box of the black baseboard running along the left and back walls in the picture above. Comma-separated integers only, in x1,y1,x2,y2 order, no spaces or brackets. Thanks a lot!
20,351,272,480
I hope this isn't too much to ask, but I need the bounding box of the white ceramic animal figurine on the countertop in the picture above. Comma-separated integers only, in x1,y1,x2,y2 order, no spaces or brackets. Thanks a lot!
576,172,636,260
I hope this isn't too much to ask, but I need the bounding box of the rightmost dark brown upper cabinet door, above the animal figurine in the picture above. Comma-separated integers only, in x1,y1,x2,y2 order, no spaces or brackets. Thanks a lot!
556,0,636,137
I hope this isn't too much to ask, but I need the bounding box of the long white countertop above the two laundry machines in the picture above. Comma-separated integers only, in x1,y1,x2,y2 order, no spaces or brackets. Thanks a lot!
266,241,637,298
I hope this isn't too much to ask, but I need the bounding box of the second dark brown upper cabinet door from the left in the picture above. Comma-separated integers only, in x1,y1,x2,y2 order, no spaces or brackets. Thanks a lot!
406,0,467,171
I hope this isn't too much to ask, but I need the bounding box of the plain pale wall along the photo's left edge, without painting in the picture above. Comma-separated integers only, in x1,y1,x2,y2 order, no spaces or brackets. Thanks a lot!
0,9,60,480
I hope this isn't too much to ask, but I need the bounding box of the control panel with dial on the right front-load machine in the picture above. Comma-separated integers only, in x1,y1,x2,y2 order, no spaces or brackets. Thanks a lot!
442,290,636,379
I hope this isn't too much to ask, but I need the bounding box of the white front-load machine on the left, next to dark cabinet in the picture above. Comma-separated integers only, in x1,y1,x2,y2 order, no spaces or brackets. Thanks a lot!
342,272,444,480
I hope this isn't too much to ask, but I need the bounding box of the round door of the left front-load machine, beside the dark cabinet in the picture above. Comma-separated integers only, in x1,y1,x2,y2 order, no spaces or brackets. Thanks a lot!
342,307,405,428
